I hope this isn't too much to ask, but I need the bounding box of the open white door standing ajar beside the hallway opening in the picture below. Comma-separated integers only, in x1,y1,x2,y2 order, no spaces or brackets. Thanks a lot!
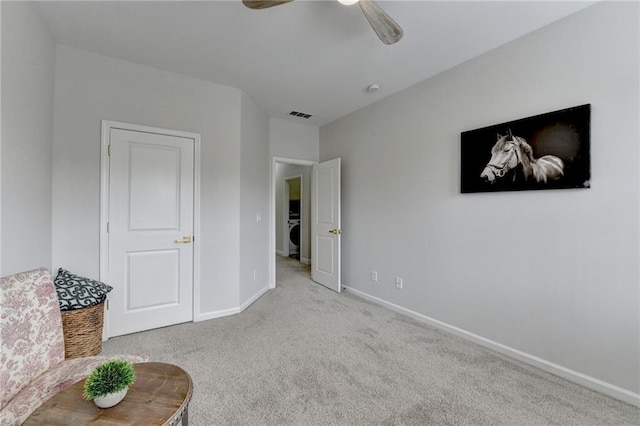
311,158,342,293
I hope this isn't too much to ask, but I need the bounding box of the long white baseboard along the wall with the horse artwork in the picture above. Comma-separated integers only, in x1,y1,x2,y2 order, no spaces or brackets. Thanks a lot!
344,286,640,407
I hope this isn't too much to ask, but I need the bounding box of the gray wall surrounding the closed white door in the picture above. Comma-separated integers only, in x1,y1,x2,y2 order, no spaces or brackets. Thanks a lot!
53,46,245,319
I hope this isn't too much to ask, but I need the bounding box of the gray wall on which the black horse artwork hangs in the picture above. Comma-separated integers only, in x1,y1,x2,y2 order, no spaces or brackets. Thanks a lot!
320,2,640,398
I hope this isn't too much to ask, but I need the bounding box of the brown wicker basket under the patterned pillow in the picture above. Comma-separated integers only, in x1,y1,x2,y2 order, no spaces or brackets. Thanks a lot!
61,302,104,359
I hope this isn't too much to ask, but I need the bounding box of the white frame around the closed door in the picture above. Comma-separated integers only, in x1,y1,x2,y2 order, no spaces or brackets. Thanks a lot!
99,120,200,340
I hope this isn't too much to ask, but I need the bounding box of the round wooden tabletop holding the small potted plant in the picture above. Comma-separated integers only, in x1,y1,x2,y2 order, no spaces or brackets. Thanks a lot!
23,362,193,426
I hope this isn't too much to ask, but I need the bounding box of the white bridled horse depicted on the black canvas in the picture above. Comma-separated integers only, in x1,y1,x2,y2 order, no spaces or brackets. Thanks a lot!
480,131,564,184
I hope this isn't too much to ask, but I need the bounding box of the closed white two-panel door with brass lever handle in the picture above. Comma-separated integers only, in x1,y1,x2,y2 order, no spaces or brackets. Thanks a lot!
108,128,195,336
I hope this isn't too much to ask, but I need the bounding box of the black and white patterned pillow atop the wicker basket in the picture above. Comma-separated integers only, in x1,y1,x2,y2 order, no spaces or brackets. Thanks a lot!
53,268,113,311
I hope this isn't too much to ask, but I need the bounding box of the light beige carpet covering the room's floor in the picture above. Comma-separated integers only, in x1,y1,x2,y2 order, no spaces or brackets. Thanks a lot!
103,257,640,426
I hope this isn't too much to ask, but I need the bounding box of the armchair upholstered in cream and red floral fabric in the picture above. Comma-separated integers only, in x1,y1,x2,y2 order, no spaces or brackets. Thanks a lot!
0,268,148,426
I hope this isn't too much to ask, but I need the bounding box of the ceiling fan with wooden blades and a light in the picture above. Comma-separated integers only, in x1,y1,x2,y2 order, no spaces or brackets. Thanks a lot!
242,0,404,44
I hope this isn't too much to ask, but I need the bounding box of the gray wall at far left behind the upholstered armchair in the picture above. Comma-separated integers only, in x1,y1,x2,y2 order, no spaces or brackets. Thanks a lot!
0,2,55,275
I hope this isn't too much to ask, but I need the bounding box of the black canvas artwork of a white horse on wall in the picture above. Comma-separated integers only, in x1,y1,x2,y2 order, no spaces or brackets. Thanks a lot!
460,104,591,193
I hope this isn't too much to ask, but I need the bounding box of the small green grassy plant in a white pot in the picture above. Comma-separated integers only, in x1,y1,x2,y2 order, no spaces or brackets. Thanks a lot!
83,359,136,408
